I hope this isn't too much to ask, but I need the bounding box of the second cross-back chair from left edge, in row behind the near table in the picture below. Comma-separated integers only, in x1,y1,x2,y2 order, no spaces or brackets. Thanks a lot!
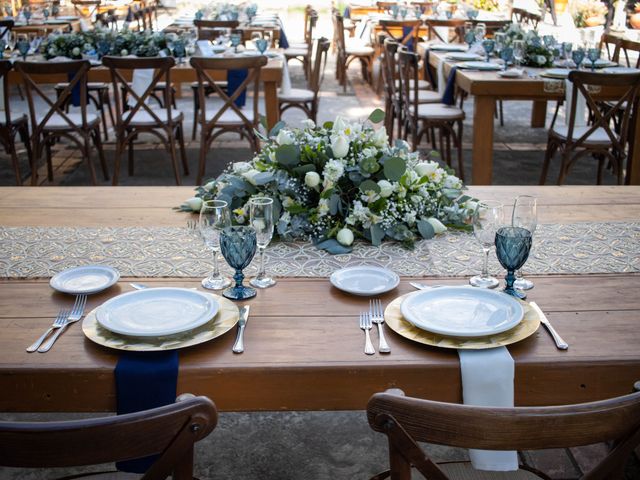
15,60,109,185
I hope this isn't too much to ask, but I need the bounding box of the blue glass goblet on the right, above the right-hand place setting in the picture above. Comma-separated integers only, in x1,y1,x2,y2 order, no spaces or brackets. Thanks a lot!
496,227,531,300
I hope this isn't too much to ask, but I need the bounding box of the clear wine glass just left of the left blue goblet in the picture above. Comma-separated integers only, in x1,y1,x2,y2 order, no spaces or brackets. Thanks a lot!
198,200,231,290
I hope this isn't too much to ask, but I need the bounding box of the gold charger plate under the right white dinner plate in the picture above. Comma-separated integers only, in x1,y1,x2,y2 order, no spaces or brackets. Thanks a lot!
384,294,540,350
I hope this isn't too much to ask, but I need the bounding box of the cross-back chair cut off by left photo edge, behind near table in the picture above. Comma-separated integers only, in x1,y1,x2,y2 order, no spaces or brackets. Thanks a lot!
0,60,33,185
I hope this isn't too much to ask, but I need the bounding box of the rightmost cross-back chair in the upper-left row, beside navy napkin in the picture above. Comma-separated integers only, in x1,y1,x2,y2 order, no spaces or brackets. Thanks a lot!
190,55,267,185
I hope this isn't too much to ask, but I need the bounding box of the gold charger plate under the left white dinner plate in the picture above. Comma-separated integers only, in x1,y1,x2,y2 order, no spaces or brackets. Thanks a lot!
82,294,240,352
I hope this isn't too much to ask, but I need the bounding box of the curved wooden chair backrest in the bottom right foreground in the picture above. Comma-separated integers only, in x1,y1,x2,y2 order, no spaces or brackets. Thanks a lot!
367,390,640,480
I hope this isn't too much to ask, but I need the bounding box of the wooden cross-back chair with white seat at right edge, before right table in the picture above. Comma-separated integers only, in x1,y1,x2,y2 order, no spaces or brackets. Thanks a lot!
540,71,640,185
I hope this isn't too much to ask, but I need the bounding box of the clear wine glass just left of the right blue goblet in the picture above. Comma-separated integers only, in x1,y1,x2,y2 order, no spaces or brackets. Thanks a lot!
469,200,503,288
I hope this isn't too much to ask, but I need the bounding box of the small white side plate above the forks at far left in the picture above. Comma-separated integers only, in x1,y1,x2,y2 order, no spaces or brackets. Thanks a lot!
49,265,120,295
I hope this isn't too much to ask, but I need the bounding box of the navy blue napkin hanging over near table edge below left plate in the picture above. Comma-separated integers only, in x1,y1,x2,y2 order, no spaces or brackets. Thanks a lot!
115,350,178,473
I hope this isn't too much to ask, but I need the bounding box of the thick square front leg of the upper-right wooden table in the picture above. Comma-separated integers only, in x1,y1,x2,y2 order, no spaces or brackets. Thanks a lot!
471,95,496,185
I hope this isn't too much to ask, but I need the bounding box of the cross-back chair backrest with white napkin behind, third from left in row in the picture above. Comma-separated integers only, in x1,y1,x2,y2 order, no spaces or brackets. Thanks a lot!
102,56,176,129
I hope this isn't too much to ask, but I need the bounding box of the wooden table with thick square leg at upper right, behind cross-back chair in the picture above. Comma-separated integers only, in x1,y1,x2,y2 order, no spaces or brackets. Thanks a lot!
429,50,640,185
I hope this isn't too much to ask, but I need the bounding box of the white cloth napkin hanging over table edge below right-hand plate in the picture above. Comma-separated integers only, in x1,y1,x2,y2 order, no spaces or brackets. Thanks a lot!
458,347,518,472
